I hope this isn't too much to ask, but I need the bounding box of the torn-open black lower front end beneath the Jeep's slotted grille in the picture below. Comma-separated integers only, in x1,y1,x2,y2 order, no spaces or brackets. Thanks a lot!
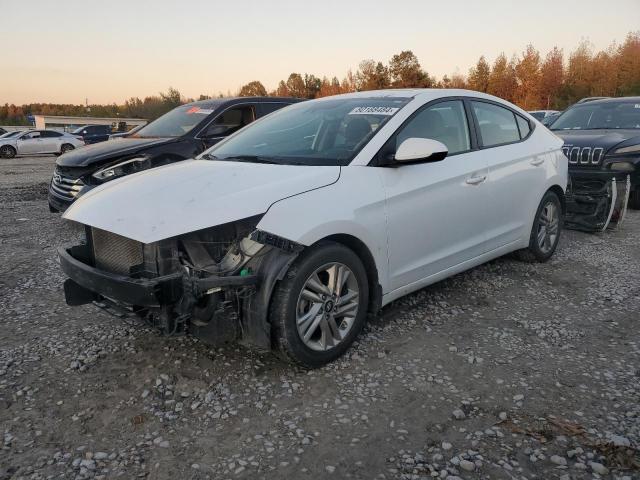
565,170,631,232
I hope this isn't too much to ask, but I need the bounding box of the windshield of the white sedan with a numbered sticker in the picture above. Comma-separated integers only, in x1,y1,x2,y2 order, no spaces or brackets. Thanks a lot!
203,97,410,165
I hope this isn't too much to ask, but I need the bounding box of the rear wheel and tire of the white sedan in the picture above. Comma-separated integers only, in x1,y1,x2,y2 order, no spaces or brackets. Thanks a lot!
516,190,564,263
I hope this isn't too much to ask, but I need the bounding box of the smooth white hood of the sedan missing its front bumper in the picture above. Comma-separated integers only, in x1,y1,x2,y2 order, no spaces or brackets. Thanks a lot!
63,160,340,243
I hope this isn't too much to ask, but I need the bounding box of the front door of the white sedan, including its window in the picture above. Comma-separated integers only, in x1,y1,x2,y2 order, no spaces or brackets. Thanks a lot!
380,100,488,290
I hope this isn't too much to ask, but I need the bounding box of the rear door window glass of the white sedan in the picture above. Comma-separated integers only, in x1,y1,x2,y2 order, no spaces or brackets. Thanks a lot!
471,101,520,147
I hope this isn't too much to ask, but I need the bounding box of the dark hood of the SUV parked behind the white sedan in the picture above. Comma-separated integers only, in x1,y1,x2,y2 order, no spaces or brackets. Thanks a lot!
56,138,177,167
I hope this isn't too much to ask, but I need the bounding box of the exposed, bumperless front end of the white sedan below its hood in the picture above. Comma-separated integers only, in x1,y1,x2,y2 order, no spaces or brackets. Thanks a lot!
59,216,302,350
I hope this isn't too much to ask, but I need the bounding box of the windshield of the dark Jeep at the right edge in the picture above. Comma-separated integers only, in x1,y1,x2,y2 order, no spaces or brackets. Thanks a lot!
551,101,640,130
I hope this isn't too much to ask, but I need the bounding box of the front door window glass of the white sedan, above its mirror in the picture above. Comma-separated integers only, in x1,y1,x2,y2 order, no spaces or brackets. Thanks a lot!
395,100,471,154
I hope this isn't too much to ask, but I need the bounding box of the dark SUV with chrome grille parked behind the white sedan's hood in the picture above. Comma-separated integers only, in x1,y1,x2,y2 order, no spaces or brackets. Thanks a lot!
49,97,301,212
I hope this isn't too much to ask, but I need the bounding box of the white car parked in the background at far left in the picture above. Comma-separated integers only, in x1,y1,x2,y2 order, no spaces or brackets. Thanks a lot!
0,130,84,158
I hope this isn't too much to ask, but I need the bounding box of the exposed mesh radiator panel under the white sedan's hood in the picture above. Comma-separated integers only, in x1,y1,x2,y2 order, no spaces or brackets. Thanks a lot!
91,228,143,275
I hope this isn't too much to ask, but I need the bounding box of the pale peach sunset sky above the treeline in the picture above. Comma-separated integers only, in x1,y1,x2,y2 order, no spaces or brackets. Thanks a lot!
0,0,640,104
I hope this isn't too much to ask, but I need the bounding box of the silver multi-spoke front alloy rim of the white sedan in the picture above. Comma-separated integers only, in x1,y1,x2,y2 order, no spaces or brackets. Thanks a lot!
296,262,360,351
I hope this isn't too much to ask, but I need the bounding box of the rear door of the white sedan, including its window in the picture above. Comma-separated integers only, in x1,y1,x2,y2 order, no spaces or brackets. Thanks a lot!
469,99,549,250
